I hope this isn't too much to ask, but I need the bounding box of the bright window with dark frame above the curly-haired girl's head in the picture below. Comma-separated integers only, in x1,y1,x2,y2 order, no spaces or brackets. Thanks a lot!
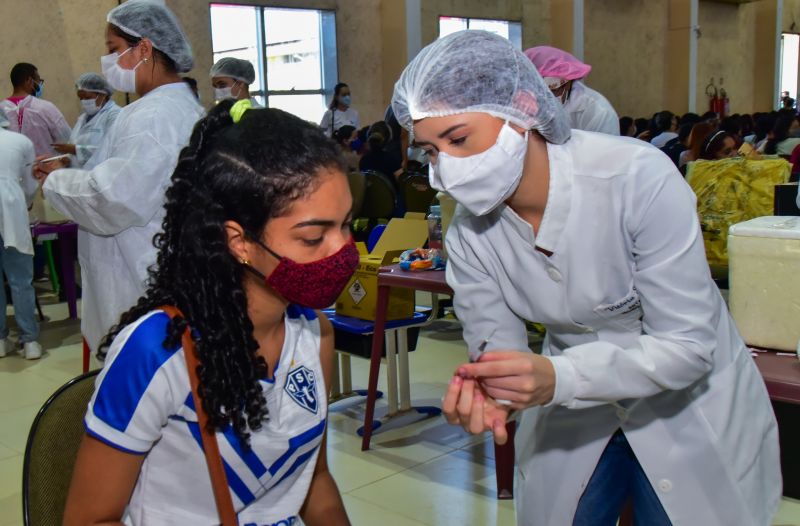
211,4,338,122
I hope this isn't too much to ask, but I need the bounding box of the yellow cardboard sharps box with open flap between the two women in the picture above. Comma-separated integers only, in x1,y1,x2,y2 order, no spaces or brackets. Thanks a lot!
336,216,428,320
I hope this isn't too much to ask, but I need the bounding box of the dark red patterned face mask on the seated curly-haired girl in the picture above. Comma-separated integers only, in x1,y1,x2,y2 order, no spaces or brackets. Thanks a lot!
245,238,358,309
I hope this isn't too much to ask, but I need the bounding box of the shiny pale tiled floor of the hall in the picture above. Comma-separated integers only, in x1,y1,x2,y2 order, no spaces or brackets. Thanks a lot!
0,294,800,526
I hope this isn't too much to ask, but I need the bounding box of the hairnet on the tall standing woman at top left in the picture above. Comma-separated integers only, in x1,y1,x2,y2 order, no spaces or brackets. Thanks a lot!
106,0,194,73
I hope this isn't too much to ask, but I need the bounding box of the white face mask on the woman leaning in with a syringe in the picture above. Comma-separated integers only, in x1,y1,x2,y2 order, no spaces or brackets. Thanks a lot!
429,122,528,216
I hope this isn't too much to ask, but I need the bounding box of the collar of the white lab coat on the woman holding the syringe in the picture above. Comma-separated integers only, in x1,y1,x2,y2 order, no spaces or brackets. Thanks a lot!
502,141,572,253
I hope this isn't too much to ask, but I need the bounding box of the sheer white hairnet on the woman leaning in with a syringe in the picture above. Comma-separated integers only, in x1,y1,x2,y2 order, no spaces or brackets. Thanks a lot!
392,30,570,144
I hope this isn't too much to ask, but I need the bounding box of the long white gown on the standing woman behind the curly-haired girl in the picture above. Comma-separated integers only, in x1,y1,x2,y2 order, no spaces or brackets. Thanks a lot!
43,82,203,351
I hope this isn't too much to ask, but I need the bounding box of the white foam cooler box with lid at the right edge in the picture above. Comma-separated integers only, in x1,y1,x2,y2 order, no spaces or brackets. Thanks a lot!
728,216,800,351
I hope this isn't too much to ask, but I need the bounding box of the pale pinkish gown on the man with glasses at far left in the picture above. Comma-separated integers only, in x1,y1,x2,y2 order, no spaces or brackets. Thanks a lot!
0,95,70,155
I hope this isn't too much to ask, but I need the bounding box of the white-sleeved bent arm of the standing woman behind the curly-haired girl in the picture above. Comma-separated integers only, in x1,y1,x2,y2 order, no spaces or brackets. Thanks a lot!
42,122,176,235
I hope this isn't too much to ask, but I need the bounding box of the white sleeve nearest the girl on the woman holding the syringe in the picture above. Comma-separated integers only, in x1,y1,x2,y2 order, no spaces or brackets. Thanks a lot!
445,213,528,359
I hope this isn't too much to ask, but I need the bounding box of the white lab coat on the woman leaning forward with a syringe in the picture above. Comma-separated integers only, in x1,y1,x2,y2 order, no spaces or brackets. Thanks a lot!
446,131,782,526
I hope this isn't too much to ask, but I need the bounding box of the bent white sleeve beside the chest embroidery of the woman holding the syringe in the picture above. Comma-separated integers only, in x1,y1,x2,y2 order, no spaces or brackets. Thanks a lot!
550,150,721,408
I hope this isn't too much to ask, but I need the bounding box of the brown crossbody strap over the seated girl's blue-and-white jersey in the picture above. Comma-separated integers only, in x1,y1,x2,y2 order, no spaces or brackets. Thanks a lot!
161,305,239,526
